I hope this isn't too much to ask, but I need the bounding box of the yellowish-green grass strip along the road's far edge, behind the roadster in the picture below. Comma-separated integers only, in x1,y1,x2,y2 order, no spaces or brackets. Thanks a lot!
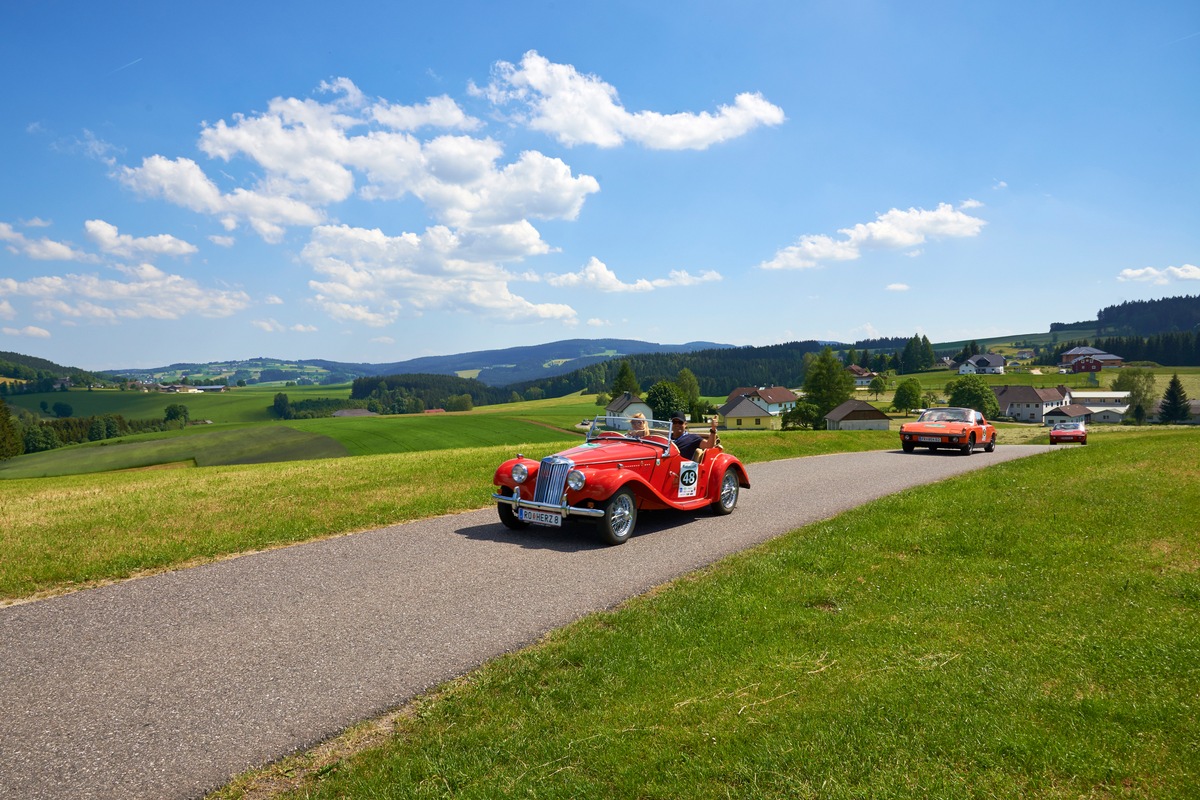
0,421,895,602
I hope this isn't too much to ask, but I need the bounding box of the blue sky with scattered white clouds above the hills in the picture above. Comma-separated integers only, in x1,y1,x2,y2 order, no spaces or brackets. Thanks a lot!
0,0,1200,369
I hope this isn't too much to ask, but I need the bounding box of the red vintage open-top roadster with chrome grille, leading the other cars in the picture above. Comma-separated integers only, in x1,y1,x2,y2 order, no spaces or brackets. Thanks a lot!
492,415,750,545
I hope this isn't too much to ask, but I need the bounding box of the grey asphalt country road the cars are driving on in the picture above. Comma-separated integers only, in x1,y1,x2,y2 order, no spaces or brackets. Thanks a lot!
0,445,1050,800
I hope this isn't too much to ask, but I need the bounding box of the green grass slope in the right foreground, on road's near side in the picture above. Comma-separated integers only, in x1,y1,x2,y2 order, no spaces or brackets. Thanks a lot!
226,431,1200,799
